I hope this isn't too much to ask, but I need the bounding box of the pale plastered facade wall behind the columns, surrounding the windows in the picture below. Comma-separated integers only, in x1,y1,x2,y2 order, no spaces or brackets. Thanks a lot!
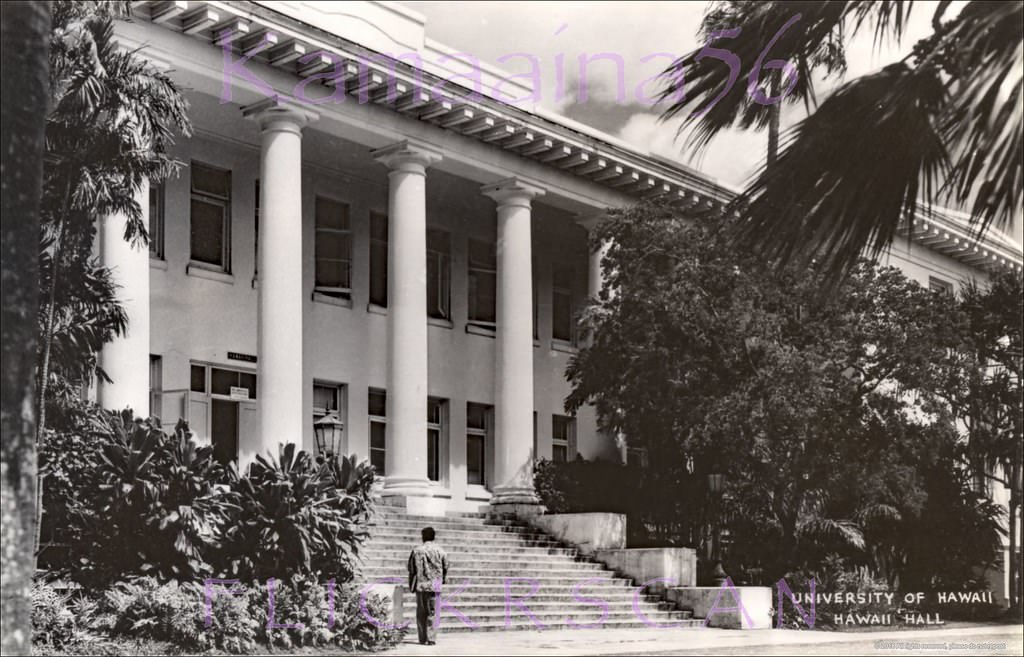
151,99,617,509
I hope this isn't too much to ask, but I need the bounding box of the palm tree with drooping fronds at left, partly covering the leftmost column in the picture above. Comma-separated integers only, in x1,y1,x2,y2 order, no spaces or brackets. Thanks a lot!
38,1,189,433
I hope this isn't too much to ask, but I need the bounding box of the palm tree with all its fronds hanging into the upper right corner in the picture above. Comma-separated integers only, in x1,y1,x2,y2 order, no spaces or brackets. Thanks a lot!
663,0,1024,280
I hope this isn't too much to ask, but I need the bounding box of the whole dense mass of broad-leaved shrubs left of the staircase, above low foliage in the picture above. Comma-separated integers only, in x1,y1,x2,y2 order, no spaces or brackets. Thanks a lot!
41,401,373,588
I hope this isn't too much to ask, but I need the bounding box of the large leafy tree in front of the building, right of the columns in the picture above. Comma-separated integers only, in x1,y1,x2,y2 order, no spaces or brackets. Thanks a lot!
566,204,1003,580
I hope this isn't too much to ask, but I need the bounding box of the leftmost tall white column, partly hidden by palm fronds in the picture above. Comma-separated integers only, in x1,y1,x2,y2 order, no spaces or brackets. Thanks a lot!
97,180,150,418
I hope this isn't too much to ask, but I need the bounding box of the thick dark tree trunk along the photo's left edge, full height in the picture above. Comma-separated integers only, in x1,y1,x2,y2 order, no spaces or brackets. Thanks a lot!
0,2,50,655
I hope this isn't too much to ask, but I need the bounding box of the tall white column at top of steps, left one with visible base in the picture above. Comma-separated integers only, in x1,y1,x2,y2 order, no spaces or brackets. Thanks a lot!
371,141,441,496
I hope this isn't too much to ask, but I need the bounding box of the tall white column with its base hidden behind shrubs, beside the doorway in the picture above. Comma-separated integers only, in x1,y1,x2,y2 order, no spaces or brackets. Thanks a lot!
239,98,317,468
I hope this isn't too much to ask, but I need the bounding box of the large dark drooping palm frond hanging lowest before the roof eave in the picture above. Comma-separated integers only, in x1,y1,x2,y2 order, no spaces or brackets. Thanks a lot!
732,62,947,280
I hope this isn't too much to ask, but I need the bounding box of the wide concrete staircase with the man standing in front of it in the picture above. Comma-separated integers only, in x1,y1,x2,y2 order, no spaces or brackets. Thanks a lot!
359,506,701,632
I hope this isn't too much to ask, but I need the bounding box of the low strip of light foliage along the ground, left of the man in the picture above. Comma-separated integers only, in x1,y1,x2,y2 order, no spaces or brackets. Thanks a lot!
33,576,403,655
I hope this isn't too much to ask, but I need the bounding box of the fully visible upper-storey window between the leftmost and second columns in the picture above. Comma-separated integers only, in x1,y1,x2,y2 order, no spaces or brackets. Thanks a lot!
189,162,231,272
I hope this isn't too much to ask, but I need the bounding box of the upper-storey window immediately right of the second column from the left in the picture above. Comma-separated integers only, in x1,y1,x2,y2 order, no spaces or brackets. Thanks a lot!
314,196,352,299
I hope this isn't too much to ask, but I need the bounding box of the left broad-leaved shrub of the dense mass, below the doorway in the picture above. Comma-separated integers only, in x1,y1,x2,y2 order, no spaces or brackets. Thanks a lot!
46,411,234,585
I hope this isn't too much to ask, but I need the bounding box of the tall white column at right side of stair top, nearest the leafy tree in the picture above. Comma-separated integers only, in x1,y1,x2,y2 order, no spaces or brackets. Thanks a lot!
481,178,544,506
